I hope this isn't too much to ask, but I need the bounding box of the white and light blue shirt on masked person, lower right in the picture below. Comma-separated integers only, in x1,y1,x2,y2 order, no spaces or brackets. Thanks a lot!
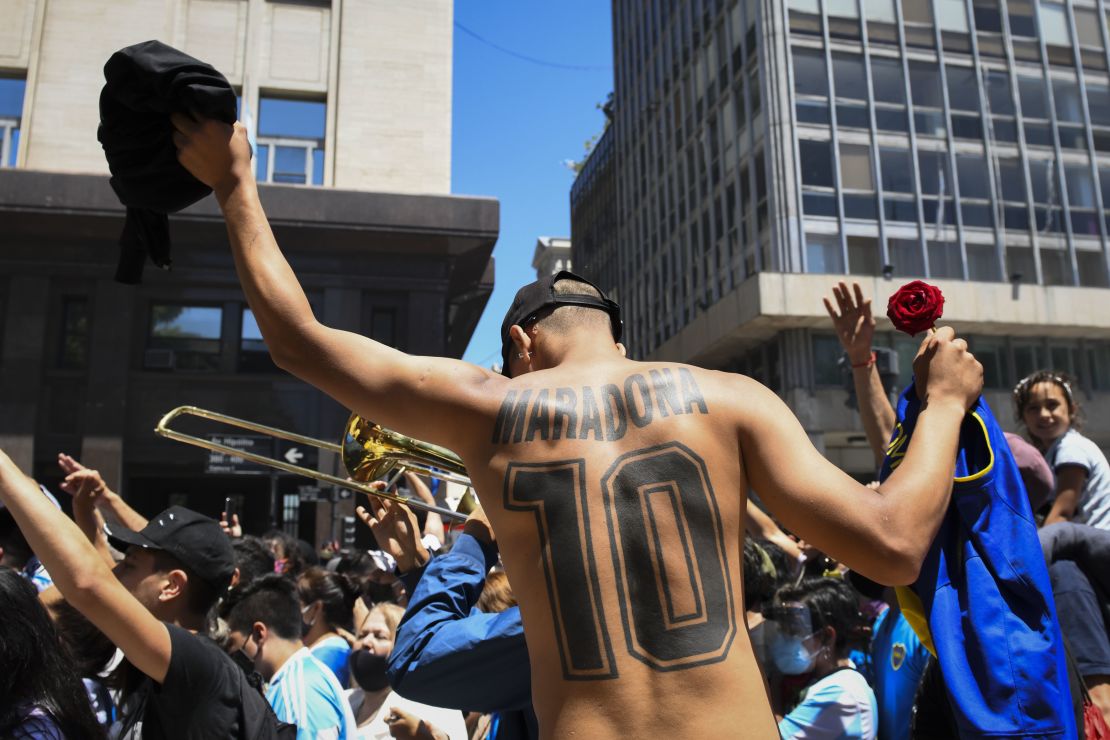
778,668,878,740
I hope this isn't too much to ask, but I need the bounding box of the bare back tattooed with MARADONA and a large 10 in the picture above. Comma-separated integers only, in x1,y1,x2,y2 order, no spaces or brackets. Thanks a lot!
471,359,777,738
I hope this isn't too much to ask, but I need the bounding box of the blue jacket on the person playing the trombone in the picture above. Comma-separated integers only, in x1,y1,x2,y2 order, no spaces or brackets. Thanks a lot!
389,535,538,740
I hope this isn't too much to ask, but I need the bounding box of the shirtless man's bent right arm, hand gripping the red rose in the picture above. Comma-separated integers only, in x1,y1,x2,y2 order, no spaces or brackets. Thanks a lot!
740,327,982,585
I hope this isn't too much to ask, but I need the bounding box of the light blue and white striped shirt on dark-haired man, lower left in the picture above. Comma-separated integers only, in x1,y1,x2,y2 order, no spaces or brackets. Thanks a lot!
266,648,356,740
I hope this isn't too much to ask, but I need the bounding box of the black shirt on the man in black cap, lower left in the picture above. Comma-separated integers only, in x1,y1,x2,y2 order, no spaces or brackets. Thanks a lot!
123,625,272,740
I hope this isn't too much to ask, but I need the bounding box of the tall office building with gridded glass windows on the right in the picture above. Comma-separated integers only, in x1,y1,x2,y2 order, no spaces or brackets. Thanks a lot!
572,0,1110,477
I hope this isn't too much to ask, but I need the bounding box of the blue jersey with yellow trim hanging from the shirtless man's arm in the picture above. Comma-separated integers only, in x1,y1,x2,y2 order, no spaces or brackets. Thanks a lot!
879,384,1076,739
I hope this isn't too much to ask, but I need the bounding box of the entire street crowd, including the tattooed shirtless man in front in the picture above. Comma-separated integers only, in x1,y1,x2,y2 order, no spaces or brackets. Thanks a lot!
0,105,1110,740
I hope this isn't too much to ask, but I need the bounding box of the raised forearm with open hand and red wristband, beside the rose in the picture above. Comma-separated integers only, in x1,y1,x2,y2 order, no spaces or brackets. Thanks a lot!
824,282,896,467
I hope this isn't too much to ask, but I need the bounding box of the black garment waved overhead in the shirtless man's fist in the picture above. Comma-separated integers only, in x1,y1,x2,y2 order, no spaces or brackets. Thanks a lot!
97,41,235,284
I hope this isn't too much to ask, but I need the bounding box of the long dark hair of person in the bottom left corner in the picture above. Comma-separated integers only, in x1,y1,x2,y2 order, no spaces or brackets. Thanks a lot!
0,568,104,738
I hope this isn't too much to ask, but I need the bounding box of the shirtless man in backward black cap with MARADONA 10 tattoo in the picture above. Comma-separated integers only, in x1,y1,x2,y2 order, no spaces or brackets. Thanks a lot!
174,115,982,738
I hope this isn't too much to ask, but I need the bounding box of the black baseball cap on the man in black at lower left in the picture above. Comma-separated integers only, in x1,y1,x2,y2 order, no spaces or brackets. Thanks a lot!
104,506,235,594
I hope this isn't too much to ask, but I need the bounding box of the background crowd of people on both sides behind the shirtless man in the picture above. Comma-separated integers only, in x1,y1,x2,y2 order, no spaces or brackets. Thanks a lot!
0,280,1110,739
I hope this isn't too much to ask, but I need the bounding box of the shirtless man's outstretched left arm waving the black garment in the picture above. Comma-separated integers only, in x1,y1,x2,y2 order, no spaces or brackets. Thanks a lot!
173,114,505,450
